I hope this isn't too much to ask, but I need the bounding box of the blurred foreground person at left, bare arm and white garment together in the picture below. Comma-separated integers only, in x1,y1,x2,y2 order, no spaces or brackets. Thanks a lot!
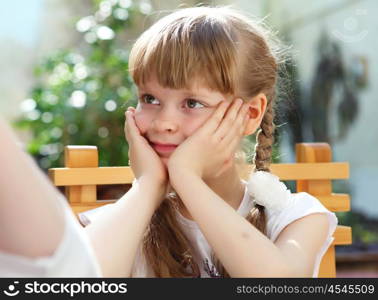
0,119,101,277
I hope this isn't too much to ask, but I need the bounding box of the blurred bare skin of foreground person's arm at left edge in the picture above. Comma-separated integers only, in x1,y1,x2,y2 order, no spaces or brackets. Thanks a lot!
0,118,64,258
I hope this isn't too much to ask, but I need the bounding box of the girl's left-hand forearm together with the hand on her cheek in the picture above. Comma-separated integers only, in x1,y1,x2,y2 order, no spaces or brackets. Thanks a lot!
86,108,167,277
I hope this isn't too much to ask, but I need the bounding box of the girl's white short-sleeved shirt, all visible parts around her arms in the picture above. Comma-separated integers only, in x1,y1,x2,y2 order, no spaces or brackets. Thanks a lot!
79,180,338,277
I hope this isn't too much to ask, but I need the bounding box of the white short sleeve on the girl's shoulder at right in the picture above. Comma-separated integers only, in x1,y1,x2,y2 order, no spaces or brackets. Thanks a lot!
267,192,338,277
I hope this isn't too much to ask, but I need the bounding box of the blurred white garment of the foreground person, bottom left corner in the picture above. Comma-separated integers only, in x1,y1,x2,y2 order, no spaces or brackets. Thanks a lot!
0,197,102,277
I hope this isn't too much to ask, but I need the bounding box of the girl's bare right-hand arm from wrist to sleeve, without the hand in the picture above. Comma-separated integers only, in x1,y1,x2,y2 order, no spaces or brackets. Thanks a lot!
171,171,328,277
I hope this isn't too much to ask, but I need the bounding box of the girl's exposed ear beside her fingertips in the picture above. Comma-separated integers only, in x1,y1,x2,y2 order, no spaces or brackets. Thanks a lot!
244,93,268,135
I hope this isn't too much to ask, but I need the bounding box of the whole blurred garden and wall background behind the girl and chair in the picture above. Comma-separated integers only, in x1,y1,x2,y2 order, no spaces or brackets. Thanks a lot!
0,0,378,277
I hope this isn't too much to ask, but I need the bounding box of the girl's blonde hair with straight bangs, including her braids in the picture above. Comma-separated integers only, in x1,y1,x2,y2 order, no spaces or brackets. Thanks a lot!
129,6,280,277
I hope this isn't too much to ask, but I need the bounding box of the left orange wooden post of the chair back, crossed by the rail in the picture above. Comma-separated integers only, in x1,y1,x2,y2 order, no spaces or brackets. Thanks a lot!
64,146,98,204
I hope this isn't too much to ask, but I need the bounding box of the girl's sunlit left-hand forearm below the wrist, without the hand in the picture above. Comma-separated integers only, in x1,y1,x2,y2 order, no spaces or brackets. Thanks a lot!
86,177,165,277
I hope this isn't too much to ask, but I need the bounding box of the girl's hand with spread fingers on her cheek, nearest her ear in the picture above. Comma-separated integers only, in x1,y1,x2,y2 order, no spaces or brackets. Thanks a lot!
168,99,248,179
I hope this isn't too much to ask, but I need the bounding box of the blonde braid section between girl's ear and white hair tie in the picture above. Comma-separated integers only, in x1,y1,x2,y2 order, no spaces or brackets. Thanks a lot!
253,98,275,172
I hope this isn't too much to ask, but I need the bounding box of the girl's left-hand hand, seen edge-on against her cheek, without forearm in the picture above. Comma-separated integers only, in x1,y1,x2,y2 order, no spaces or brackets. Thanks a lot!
125,107,168,191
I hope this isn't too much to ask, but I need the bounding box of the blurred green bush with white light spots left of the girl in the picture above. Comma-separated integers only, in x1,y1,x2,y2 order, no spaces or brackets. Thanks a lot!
15,0,152,169
